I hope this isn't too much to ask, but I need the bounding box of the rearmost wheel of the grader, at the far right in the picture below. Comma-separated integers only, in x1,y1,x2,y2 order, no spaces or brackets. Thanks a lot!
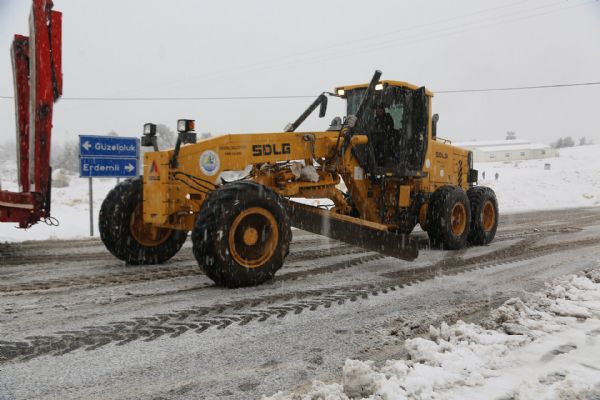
467,186,499,245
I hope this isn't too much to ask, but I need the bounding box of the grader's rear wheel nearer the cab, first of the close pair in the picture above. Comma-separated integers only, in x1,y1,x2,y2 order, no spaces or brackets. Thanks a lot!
427,186,471,250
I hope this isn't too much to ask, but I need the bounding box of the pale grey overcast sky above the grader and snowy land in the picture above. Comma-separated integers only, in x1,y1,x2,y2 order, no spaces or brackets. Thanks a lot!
0,0,600,143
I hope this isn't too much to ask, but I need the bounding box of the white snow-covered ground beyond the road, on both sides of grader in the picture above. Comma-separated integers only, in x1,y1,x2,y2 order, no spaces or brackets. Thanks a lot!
0,145,600,241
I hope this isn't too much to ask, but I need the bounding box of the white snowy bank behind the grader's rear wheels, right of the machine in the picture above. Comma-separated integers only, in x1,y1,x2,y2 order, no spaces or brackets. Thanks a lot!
475,145,600,212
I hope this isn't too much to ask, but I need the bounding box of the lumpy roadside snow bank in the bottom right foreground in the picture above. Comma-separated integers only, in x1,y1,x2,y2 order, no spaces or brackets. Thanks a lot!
263,270,600,400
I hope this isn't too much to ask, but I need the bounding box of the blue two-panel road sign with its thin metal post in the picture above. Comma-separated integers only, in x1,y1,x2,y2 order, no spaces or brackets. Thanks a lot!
79,135,140,236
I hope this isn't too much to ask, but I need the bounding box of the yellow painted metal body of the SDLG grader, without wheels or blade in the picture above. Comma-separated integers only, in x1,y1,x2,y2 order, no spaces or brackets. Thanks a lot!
143,81,469,230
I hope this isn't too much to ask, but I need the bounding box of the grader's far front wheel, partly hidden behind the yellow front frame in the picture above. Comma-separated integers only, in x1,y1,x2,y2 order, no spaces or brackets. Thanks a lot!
98,178,187,265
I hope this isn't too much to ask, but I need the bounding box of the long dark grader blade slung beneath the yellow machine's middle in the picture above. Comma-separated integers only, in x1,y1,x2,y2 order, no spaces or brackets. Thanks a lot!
286,200,419,261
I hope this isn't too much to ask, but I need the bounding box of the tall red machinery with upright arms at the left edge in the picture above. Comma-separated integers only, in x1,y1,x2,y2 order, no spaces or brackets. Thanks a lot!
0,0,62,228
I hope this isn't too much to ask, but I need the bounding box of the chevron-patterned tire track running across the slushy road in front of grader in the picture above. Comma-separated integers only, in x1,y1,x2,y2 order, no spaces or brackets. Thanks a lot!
0,237,600,363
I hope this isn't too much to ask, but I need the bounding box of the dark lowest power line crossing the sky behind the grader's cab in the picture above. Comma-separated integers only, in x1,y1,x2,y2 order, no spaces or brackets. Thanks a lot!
0,82,600,101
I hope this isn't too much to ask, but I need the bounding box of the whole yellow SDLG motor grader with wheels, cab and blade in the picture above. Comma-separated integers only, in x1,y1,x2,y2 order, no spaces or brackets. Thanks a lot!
99,71,498,287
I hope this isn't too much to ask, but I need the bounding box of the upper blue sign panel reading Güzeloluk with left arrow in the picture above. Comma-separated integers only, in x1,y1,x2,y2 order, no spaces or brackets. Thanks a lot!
79,135,140,158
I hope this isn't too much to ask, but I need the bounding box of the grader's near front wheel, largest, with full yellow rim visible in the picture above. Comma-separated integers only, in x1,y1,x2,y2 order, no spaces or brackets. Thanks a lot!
192,181,292,288
